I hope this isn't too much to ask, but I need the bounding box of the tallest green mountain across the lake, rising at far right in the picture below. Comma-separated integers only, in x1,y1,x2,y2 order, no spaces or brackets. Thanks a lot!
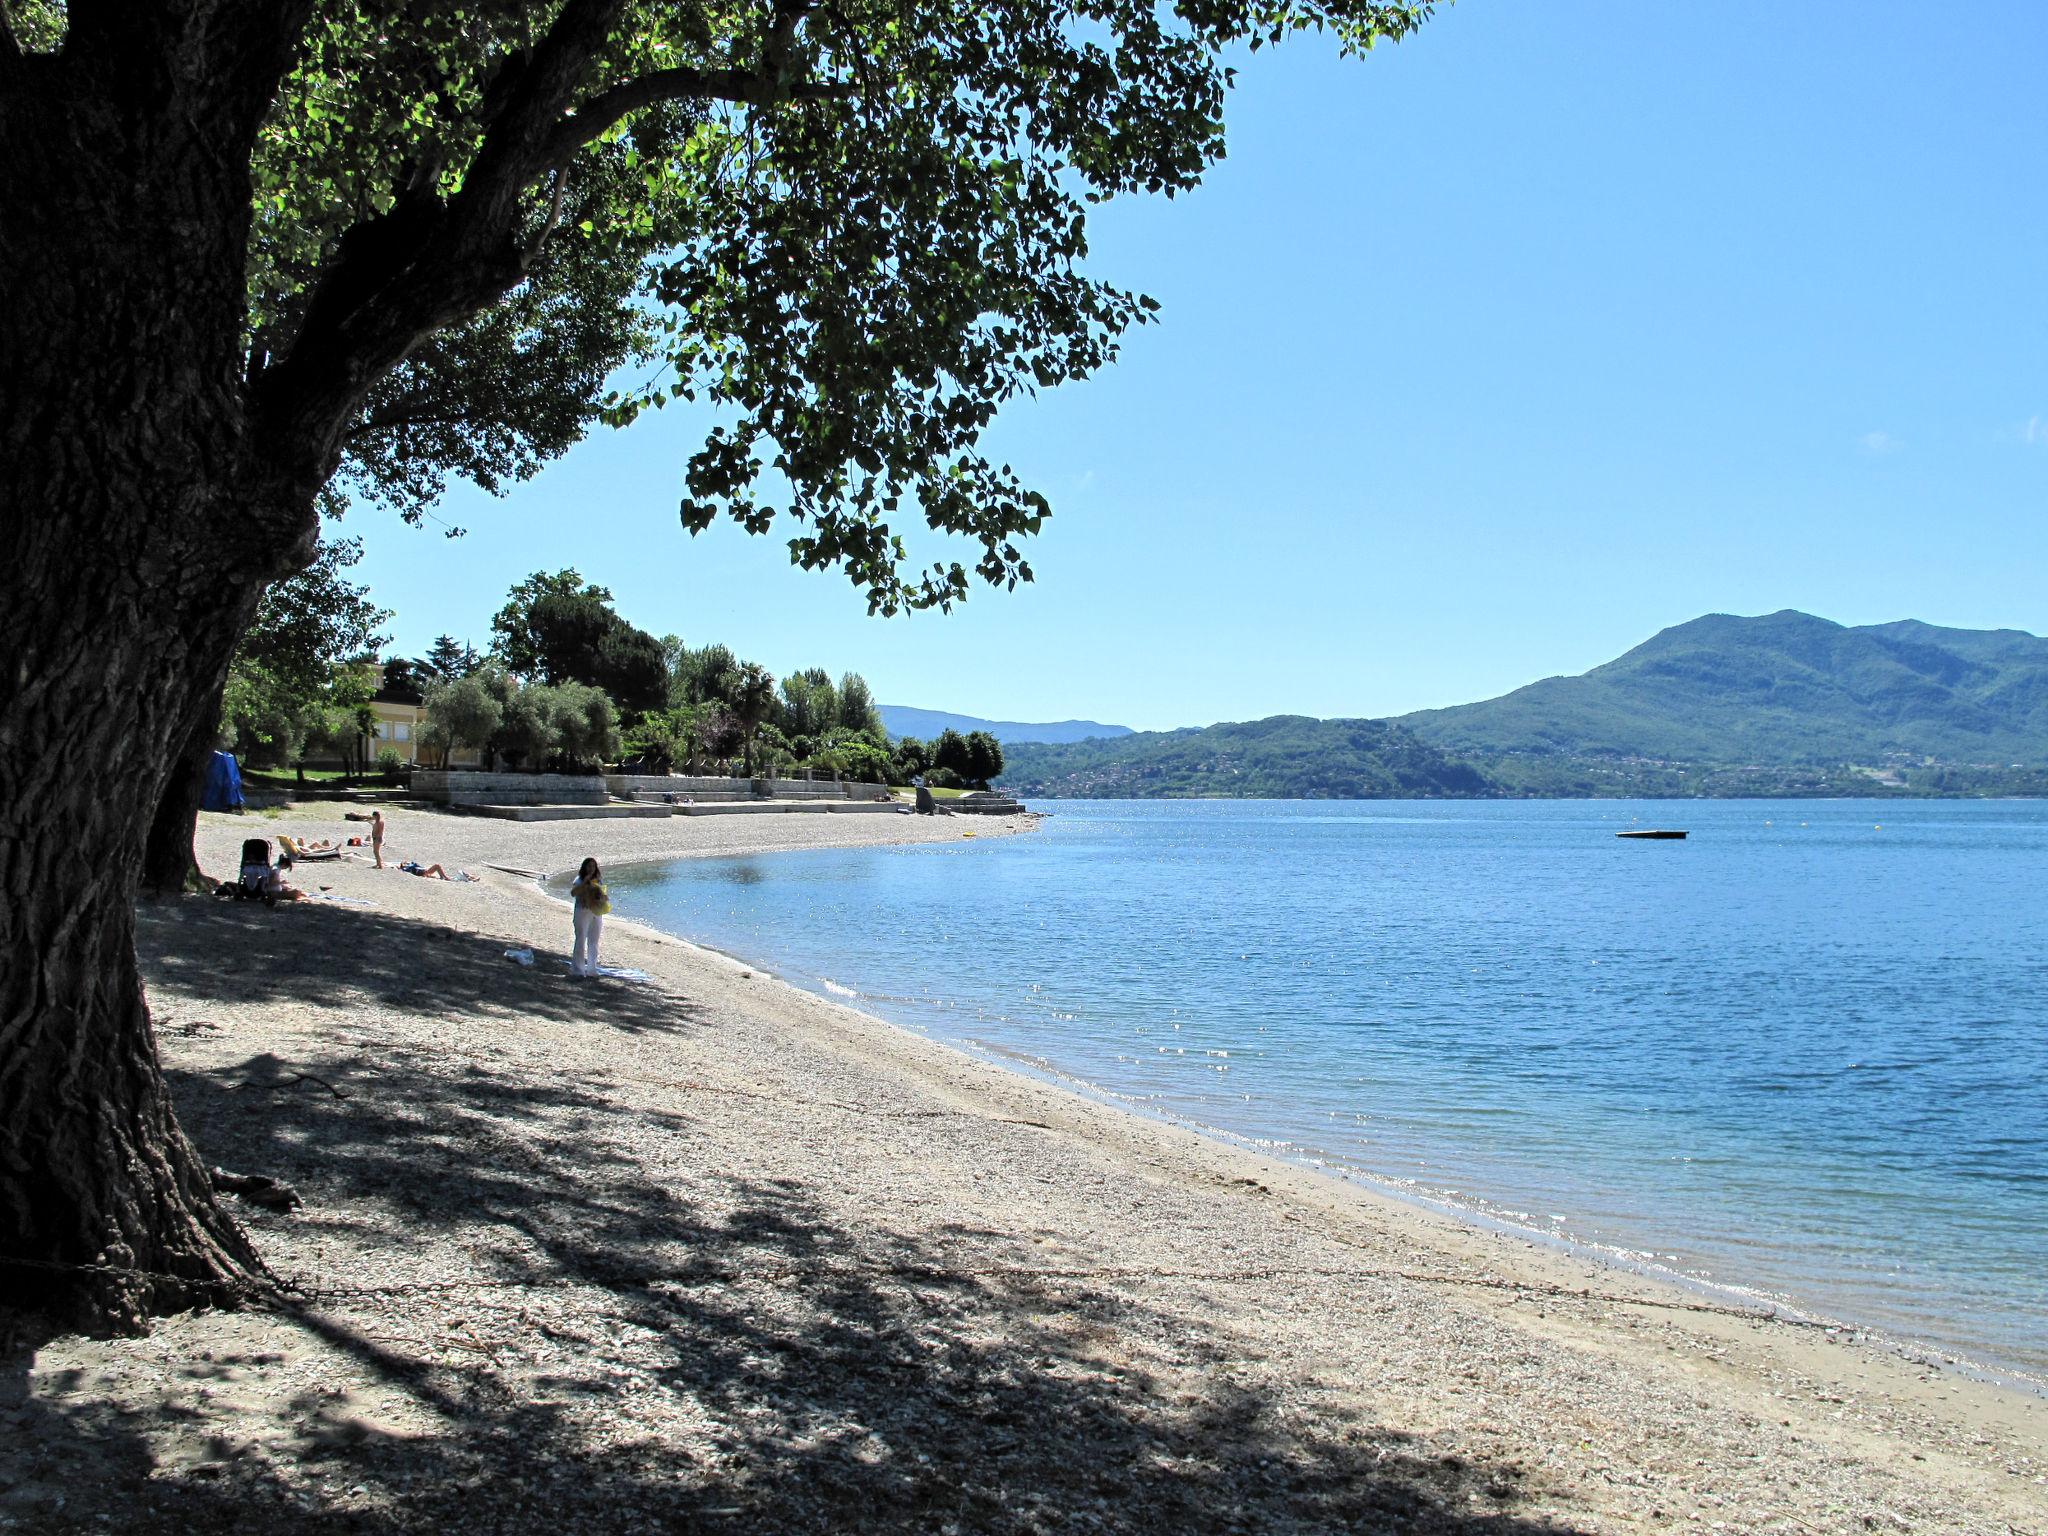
1399,608,2048,766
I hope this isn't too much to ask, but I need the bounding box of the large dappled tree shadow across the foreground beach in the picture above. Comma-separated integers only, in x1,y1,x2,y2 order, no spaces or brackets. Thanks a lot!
0,913,1597,1536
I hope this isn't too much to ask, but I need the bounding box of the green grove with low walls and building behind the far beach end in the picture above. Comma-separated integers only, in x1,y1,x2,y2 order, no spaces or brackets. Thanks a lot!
224,561,1022,821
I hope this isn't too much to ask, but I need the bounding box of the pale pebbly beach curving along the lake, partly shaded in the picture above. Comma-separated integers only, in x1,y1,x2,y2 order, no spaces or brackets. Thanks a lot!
0,813,2048,1536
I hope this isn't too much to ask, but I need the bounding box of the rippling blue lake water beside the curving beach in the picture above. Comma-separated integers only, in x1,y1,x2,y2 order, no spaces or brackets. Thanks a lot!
593,801,2048,1376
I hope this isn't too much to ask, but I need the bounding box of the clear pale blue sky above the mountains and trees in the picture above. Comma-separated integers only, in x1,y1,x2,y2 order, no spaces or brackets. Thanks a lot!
348,0,2048,729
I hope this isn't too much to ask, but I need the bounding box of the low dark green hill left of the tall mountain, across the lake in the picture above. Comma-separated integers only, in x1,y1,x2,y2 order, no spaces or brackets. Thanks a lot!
997,715,1489,801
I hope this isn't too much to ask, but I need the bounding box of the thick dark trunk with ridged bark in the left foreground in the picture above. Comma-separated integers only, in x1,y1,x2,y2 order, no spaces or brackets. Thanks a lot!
0,4,317,1329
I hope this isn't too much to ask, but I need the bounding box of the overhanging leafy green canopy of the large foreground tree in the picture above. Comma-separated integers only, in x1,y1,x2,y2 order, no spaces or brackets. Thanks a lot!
224,0,1427,618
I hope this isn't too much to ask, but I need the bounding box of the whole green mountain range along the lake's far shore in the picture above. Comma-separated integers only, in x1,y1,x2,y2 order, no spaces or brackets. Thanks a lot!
983,610,2048,799
